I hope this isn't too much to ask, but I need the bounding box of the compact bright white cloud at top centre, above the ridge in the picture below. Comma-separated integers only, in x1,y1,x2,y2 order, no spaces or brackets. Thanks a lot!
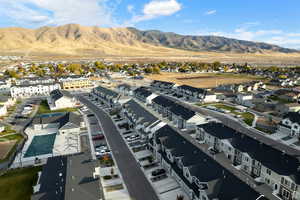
127,0,182,24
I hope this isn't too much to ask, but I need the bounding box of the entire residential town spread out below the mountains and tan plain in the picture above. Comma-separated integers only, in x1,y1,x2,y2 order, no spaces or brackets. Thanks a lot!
0,60,300,200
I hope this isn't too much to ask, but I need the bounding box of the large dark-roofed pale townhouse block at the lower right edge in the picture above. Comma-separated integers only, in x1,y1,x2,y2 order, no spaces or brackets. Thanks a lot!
196,122,300,200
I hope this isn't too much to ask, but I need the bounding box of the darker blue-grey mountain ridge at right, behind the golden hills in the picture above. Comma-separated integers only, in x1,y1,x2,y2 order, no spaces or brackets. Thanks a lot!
128,27,299,53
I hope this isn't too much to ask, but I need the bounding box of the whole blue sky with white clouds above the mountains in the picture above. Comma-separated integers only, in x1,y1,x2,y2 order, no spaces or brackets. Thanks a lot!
0,0,300,49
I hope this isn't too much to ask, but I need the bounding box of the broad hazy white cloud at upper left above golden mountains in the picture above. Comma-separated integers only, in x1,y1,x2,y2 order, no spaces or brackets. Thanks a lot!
0,0,120,26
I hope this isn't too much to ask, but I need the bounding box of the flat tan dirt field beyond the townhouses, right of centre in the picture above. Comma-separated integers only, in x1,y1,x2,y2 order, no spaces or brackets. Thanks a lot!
147,72,260,88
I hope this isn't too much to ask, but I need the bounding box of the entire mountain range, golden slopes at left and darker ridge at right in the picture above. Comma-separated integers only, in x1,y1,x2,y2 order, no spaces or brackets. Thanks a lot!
0,24,299,56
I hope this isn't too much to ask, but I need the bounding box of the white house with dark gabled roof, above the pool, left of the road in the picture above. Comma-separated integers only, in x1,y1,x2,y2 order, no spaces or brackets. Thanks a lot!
47,89,77,110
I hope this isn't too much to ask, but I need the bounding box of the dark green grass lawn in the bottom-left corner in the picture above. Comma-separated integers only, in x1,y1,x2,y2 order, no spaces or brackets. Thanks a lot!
0,167,41,200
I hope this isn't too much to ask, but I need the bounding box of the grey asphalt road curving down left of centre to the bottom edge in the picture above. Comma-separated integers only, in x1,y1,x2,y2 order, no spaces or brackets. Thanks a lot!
78,96,158,200
